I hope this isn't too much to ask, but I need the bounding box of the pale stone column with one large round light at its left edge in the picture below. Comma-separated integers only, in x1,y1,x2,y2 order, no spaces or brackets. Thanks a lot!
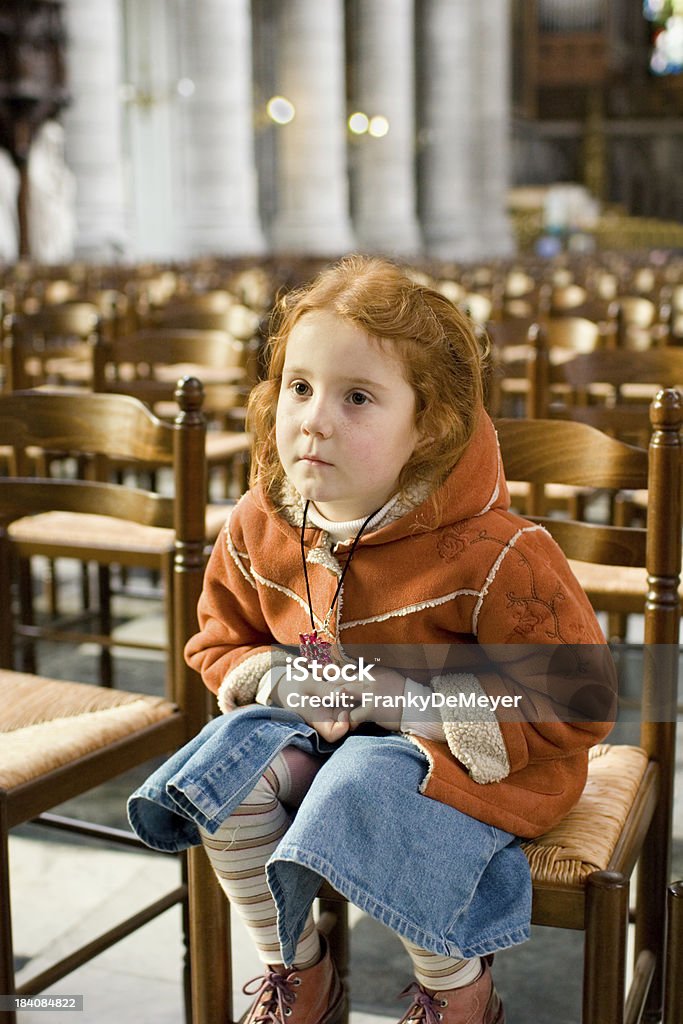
272,0,353,256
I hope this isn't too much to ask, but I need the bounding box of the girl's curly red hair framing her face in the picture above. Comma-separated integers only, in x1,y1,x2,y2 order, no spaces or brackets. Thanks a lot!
247,255,487,516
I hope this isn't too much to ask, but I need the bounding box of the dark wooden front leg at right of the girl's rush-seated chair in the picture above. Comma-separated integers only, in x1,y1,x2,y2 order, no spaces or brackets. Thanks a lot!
582,871,629,1024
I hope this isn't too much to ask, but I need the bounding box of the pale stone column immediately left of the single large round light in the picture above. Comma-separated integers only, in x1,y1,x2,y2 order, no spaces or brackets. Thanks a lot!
181,0,264,255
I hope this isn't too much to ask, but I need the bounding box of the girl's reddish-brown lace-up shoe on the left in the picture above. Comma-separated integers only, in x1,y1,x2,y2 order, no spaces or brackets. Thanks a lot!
243,937,346,1024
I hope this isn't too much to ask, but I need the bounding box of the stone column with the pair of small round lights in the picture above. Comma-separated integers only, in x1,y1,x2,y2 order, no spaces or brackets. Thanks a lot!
353,0,421,255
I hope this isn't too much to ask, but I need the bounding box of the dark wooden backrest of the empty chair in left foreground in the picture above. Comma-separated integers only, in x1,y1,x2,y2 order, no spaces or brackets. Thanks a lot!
0,377,207,735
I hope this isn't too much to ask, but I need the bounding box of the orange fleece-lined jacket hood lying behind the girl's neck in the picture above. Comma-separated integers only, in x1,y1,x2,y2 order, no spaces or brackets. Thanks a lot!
251,411,510,548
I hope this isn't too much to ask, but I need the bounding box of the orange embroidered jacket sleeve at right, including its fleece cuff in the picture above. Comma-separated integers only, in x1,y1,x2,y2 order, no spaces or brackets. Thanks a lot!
440,527,616,782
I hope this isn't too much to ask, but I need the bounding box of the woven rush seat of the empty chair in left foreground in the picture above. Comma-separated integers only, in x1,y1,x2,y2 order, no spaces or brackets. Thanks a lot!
0,670,177,793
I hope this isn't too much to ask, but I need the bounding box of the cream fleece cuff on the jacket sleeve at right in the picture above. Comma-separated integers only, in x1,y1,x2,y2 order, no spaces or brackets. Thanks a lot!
431,673,510,783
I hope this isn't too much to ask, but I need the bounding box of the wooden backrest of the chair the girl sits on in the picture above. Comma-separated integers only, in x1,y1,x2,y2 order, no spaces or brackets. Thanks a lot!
497,389,683,880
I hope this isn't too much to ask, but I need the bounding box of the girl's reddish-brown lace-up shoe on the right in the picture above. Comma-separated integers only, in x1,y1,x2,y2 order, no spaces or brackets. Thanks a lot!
399,961,505,1024
